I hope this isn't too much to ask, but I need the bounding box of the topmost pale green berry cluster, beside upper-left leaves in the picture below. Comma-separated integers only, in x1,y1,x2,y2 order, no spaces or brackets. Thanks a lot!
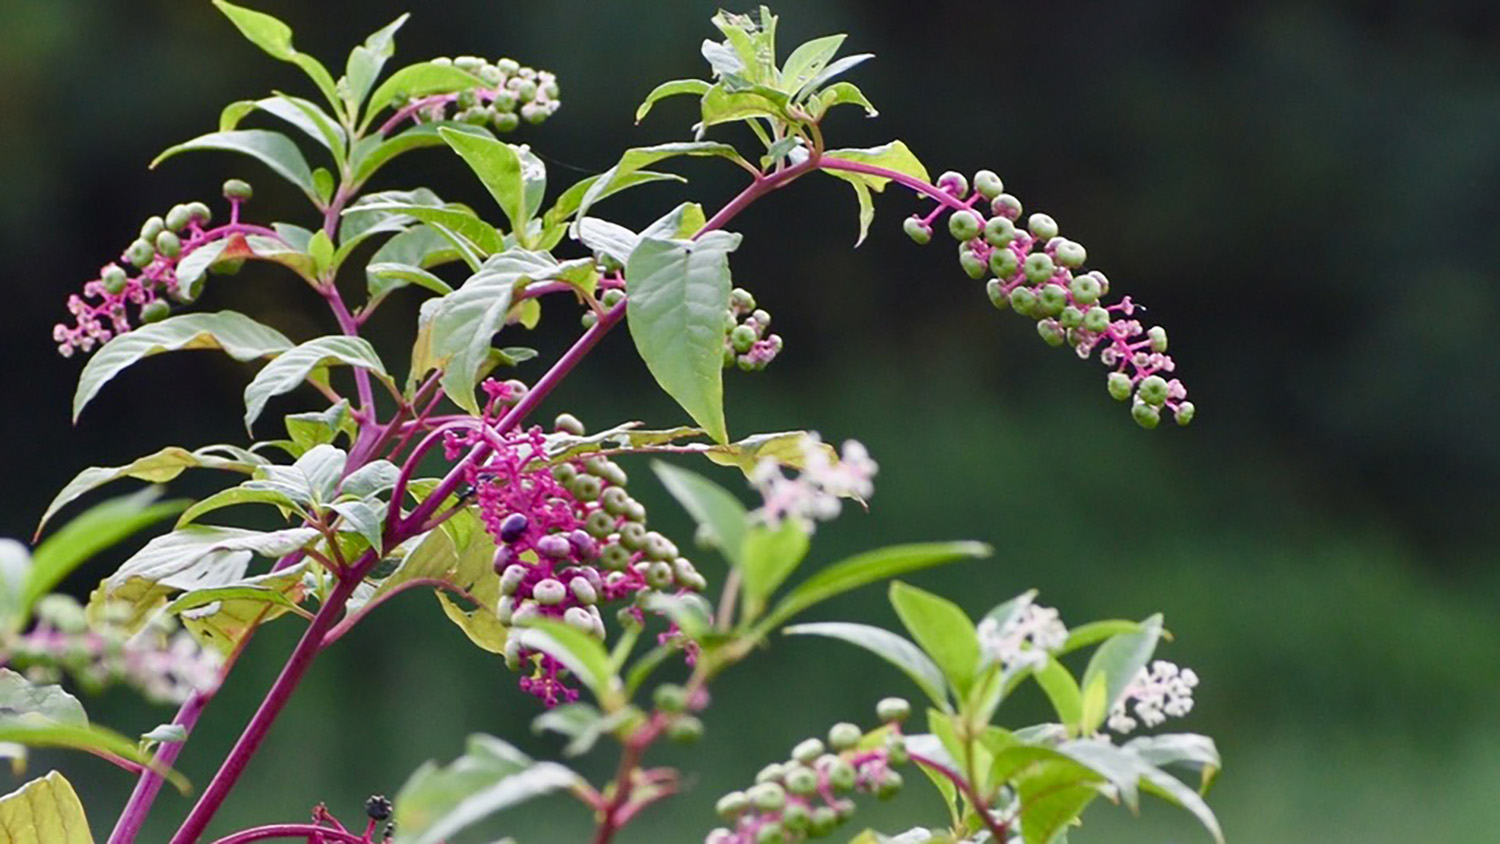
384,55,563,132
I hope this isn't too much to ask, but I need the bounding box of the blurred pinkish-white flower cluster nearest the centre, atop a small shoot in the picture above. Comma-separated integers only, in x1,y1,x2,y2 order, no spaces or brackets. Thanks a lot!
750,433,879,529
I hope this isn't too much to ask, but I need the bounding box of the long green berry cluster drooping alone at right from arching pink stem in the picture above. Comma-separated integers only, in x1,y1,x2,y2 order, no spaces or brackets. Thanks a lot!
905,169,1194,429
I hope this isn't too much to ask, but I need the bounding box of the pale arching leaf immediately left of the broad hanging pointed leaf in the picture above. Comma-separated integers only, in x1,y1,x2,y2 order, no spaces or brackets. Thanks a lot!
429,249,560,415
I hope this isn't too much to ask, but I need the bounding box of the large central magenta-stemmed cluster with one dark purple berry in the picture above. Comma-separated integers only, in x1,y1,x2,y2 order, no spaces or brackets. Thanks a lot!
444,379,708,706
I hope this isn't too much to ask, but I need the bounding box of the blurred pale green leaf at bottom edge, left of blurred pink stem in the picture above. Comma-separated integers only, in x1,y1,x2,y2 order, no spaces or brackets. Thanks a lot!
395,735,584,844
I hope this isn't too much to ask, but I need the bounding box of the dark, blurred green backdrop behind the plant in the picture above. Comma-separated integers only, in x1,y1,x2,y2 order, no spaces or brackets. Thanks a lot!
0,0,1500,844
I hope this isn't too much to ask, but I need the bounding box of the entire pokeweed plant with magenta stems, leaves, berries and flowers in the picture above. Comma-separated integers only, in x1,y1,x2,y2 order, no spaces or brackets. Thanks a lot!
0,6,1223,844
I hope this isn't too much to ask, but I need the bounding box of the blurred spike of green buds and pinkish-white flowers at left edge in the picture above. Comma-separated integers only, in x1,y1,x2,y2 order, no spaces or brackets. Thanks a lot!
3,595,222,703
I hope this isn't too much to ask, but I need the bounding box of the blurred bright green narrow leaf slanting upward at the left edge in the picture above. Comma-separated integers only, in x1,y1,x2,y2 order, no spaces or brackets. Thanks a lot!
29,489,186,618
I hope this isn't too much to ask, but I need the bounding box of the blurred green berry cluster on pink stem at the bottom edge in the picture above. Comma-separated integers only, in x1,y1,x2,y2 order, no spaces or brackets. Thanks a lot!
705,697,912,844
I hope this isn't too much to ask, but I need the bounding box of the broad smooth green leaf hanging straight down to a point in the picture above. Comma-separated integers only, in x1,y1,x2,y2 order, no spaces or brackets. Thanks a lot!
626,231,740,442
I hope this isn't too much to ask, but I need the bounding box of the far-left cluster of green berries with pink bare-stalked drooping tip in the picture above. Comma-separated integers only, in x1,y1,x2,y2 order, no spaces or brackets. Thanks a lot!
53,178,251,357
